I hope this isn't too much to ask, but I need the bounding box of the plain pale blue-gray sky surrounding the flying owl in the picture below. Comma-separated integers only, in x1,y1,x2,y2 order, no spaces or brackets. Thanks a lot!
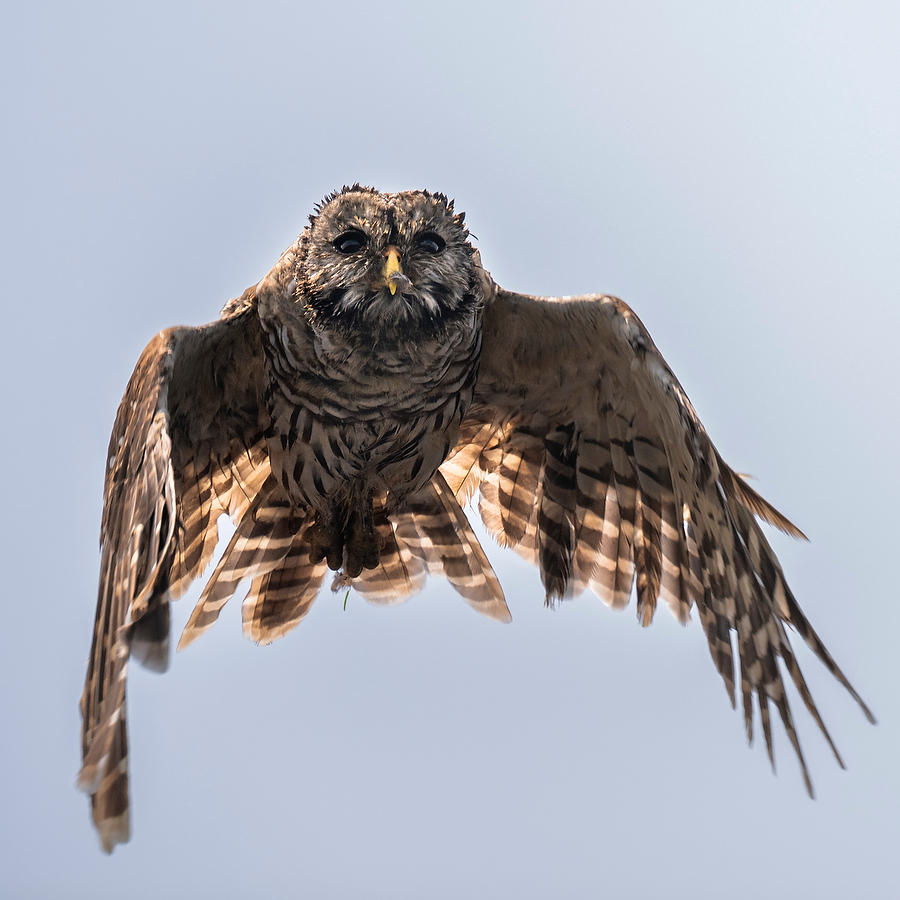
0,2,900,898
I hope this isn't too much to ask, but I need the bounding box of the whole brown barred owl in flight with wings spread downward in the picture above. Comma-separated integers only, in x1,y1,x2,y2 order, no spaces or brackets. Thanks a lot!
79,184,872,851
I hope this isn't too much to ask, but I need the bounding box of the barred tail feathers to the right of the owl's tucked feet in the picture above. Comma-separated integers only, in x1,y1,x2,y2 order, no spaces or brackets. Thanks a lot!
352,472,512,622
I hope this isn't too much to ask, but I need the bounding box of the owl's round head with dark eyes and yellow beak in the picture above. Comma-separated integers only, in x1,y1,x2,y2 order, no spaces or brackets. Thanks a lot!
297,185,482,342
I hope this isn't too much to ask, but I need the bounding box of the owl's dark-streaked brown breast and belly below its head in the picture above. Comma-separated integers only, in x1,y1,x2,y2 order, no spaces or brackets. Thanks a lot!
268,312,481,528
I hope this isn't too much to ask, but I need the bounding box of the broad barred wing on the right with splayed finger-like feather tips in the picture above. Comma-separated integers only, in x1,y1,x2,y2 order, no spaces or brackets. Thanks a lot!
442,279,874,794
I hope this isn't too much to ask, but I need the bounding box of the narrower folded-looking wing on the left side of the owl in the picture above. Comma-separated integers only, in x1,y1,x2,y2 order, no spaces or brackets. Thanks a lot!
78,298,269,851
